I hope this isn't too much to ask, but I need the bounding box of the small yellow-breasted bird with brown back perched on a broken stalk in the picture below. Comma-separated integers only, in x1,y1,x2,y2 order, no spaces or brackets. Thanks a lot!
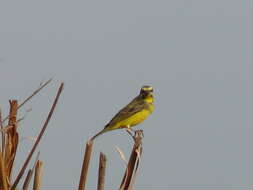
91,86,154,141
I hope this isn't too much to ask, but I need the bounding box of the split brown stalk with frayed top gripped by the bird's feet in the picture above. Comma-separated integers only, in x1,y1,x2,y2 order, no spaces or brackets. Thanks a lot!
120,130,142,190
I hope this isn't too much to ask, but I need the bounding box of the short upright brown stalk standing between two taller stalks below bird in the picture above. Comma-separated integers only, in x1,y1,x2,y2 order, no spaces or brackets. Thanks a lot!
97,152,106,190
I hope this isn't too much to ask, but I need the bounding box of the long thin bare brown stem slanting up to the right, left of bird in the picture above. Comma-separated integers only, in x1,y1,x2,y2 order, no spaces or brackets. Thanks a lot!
11,83,64,190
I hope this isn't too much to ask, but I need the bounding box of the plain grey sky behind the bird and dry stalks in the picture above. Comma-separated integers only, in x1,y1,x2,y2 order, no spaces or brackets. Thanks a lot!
0,0,253,190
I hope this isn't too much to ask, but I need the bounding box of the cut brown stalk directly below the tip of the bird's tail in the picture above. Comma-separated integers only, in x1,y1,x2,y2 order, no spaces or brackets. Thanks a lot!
78,140,93,190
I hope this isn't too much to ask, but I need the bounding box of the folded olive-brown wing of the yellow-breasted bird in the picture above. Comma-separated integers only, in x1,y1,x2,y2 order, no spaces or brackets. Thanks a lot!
106,97,147,127
